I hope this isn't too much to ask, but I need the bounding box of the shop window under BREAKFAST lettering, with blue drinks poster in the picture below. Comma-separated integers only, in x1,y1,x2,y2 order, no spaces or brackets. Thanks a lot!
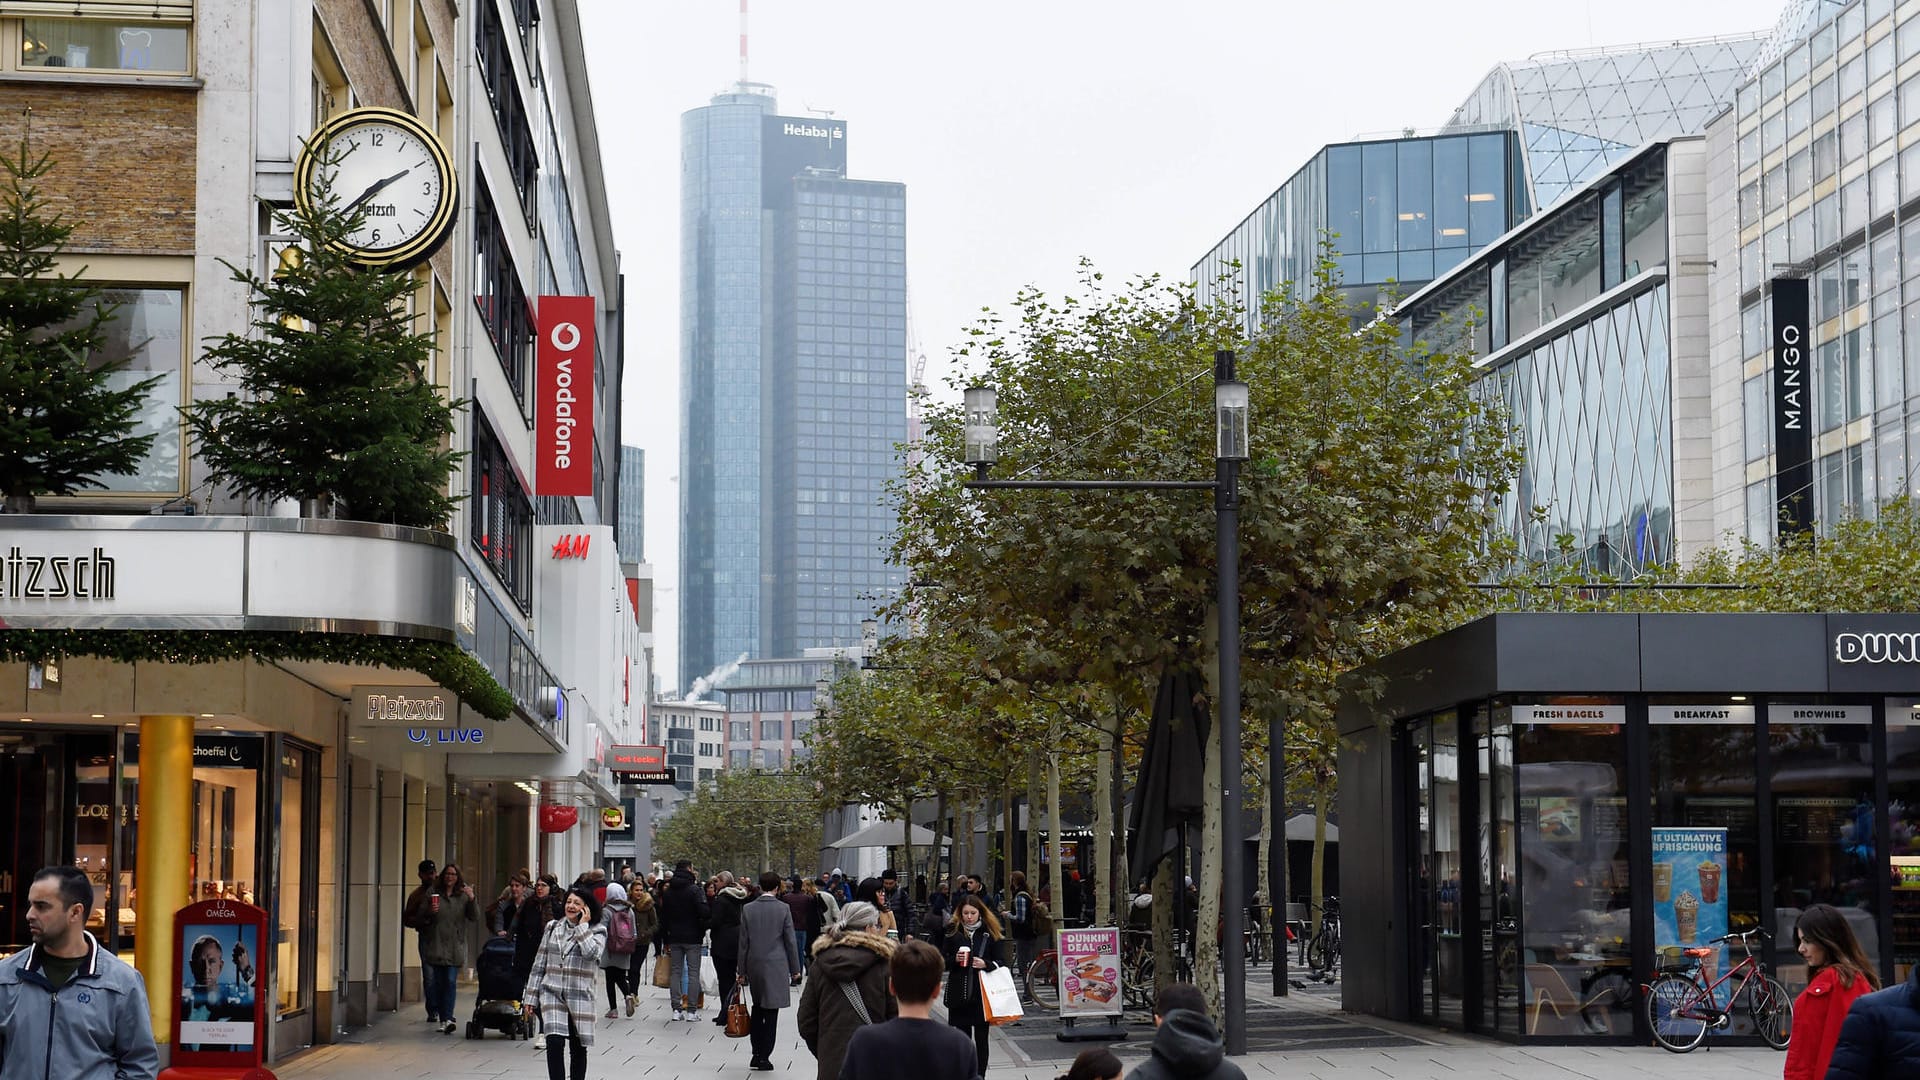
1647,698,1772,1034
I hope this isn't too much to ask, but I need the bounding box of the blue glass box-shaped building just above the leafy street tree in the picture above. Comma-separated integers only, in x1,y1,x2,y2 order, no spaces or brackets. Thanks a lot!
1192,131,1526,332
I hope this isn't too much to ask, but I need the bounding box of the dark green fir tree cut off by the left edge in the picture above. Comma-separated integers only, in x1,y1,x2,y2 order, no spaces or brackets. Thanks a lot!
0,135,159,511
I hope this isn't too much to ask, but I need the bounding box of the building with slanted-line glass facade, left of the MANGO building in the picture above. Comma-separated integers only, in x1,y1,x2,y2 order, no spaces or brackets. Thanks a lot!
1394,138,1707,573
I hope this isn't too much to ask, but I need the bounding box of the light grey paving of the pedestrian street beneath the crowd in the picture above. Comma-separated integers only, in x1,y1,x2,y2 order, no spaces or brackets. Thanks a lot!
275,953,1786,1080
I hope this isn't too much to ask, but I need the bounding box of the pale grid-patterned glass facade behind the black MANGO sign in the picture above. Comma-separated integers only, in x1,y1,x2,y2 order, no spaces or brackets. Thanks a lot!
1707,0,1920,544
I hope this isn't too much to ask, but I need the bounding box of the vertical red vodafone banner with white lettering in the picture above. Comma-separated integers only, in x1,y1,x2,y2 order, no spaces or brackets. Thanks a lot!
534,296,593,496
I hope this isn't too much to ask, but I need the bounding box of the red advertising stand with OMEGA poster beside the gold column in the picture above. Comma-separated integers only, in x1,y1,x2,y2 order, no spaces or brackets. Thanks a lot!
159,899,273,1080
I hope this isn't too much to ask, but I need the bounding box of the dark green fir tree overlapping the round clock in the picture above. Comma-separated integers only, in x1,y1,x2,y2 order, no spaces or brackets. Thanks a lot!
186,147,465,528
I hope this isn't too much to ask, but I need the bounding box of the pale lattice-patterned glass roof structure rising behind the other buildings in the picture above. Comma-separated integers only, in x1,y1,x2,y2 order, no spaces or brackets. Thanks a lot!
1446,35,1766,208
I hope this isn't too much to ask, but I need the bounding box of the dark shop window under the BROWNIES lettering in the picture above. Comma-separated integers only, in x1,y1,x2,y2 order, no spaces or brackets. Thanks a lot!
1766,703,1880,994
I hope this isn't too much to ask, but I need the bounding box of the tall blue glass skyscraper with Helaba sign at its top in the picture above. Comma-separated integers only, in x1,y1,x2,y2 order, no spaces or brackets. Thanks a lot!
680,83,906,686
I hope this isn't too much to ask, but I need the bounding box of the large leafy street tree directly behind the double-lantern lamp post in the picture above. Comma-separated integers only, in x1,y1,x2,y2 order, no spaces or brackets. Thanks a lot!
895,261,1513,1006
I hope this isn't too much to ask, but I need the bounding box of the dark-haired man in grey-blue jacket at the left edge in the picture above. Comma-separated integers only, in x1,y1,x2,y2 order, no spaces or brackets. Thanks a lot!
0,867,159,1080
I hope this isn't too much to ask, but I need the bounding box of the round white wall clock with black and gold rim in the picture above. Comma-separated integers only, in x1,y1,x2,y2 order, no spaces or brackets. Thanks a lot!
294,108,457,269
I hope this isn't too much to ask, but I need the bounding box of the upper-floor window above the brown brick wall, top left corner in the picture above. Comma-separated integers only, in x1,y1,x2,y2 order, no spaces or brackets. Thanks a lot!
0,0,194,75
